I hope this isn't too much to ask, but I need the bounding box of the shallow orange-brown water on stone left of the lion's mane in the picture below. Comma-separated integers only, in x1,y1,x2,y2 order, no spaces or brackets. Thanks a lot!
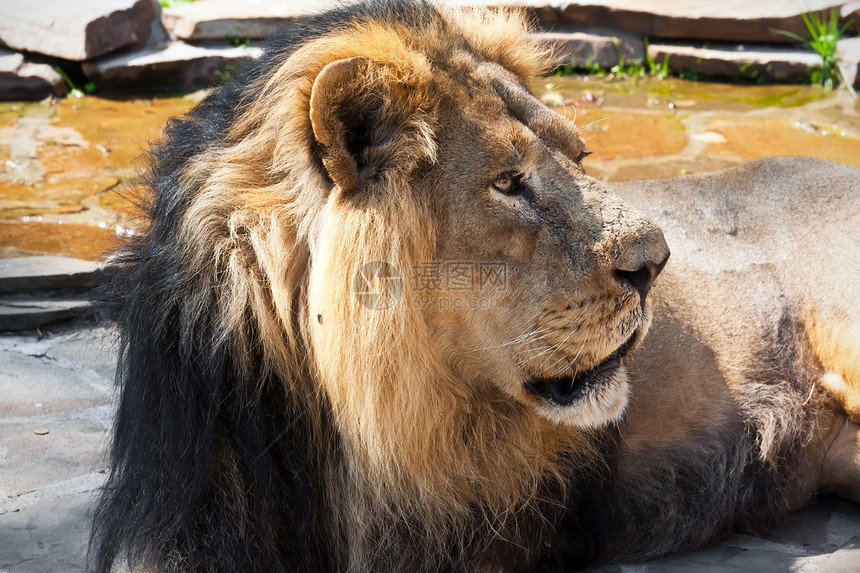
0,97,194,259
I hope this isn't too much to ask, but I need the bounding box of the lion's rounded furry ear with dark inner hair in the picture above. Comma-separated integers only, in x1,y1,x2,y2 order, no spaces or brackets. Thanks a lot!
310,57,433,193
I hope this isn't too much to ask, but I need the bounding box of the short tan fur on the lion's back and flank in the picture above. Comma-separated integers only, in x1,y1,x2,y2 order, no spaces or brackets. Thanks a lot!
616,158,860,510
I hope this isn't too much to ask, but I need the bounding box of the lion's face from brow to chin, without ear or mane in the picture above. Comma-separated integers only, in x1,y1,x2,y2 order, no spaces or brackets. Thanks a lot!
417,67,669,428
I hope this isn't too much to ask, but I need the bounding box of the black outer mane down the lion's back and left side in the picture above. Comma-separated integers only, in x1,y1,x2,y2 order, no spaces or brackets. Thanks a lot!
89,5,444,572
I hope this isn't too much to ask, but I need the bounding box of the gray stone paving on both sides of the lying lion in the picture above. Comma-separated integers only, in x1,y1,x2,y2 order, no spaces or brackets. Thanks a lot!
0,326,860,573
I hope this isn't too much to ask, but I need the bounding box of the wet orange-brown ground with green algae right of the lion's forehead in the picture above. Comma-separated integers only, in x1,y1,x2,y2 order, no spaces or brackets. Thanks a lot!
535,77,860,181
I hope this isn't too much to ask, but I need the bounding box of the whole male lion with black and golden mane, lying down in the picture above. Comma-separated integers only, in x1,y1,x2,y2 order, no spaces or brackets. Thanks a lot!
91,2,860,572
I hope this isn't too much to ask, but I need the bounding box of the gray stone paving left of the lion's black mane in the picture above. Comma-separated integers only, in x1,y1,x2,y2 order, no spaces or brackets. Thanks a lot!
0,327,114,573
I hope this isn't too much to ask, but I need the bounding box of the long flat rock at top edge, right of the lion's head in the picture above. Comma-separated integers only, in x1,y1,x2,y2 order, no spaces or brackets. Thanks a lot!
562,0,844,43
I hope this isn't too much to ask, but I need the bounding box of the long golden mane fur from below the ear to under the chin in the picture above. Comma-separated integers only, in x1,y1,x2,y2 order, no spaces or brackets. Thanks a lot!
298,156,578,551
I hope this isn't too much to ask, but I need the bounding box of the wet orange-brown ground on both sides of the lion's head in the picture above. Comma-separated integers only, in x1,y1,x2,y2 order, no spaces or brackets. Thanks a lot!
0,77,860,260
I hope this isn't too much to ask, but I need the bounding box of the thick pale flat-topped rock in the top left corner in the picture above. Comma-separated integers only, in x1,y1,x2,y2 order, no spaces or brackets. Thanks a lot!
0,0,155,61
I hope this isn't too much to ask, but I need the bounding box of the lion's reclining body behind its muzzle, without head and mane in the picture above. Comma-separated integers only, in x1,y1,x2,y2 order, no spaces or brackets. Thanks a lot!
604,157,860,553
